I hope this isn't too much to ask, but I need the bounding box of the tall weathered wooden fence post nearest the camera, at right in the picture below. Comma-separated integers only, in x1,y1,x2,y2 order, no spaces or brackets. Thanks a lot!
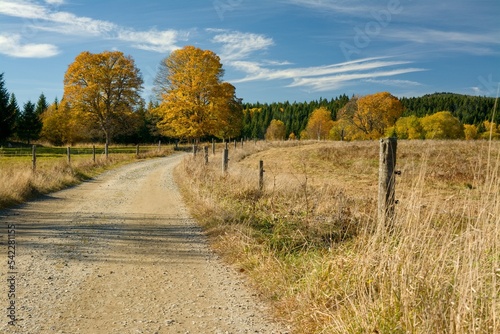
378,137,398,229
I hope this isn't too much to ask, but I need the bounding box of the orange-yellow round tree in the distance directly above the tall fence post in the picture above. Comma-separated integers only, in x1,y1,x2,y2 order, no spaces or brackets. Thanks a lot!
352,92,403,139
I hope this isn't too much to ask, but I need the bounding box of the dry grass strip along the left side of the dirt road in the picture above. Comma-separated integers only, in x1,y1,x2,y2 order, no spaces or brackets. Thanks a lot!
0,146,173,209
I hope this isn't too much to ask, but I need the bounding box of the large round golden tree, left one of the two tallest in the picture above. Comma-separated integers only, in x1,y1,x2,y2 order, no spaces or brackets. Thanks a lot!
63,51,143,143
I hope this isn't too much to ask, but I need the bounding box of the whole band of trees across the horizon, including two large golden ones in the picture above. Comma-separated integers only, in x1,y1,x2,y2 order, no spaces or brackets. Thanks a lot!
0,52,500,145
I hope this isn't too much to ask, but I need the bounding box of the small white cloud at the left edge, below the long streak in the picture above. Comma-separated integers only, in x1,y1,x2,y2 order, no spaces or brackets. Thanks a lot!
0,34,59,58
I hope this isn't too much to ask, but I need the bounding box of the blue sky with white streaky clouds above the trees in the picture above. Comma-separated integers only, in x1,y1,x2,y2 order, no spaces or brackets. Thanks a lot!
0,0,500,106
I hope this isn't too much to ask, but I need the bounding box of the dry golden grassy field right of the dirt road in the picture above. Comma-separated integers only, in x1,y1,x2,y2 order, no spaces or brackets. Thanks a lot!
177,141,500,333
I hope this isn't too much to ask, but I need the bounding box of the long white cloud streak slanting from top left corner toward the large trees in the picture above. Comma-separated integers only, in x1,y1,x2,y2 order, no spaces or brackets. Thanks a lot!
0,0,188,57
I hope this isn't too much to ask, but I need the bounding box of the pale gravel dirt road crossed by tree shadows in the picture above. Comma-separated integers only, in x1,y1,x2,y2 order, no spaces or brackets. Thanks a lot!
0,154,288,334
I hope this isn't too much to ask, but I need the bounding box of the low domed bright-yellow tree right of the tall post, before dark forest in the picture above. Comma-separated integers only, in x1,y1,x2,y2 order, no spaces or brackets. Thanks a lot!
420,111,464,139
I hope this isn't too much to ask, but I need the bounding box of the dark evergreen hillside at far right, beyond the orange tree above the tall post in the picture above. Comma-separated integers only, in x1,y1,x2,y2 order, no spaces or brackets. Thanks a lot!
399,93,500,125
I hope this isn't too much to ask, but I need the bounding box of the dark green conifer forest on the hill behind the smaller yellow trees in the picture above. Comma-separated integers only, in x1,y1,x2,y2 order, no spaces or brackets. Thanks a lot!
242,93,500,138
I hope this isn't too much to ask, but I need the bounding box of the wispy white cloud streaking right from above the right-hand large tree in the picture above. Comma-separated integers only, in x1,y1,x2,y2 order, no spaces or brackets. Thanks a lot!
212,31,425,91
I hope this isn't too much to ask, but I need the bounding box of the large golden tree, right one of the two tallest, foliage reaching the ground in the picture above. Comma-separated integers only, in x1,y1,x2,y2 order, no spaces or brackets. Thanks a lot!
155,46,243,140
